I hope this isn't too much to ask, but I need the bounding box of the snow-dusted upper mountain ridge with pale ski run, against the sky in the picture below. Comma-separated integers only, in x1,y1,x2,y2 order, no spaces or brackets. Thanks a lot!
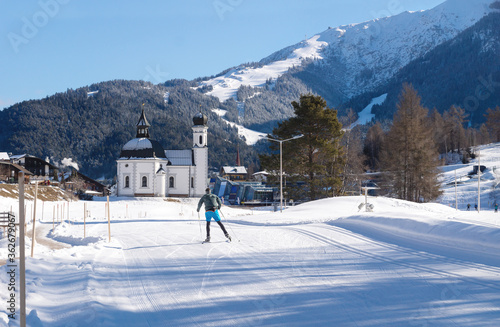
200,0,495,101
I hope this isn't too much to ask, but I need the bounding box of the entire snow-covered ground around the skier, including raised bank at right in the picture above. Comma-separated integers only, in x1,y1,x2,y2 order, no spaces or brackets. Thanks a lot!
0,144,500,326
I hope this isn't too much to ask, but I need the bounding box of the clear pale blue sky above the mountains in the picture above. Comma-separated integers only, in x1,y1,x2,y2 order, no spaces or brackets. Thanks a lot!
0,0,444,109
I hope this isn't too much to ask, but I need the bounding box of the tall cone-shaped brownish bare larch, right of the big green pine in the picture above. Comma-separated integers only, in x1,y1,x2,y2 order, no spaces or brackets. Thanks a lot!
381,84,441,202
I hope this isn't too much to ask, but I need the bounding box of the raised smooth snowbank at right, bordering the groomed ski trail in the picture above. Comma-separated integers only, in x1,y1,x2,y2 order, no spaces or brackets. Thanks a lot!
233,197,500,263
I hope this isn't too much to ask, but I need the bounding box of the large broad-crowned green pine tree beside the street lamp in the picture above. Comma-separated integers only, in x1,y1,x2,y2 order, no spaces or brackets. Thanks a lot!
260,94,344,200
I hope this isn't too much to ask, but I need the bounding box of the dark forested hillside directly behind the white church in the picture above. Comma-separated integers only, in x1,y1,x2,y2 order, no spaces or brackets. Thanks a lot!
0,80,257,178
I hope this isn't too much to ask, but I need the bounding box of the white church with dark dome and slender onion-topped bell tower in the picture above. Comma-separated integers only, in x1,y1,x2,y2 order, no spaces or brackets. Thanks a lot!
116,109,208,197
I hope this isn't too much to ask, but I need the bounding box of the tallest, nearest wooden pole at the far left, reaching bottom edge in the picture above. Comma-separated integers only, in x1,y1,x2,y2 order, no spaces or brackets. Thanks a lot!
17,171,26,327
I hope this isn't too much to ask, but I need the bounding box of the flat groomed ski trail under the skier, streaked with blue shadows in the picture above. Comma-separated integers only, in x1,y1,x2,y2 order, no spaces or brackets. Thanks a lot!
5,214,500,326
